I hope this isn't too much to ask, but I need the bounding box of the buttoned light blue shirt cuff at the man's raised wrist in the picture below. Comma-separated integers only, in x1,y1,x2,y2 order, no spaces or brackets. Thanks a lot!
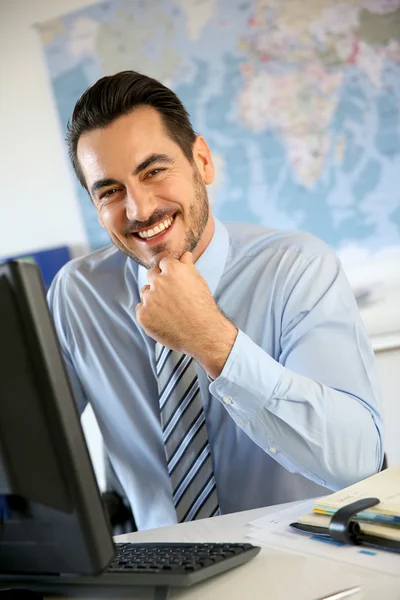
209,329,285,422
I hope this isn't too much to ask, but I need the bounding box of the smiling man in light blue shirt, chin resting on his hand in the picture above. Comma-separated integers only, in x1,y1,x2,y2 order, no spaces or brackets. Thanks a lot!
49,71,383,529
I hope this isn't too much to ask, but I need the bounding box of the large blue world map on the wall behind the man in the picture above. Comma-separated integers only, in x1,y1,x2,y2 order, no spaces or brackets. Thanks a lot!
39,0,400,262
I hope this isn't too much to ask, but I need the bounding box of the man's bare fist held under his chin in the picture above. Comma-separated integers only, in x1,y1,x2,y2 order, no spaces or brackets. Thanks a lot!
136,252,237,379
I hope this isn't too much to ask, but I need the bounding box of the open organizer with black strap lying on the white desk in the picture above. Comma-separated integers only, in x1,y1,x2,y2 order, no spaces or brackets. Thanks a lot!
291,465,400,551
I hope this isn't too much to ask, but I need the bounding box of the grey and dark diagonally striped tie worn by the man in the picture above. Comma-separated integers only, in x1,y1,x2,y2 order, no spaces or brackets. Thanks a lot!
156,343,219,523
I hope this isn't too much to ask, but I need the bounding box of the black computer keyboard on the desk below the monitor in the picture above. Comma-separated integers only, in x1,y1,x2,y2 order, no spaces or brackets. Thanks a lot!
0,543,261,598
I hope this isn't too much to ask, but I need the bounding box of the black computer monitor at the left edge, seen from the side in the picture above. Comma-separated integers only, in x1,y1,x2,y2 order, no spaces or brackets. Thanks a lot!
0,261,114,580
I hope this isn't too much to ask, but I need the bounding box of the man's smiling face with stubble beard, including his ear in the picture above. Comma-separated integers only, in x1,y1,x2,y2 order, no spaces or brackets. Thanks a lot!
78,107,214,268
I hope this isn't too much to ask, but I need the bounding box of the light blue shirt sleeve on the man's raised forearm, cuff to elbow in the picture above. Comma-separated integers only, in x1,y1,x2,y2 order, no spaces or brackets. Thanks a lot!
210,332,382,489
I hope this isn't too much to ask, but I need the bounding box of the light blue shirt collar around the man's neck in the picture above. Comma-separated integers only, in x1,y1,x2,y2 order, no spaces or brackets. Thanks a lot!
138,217,229,295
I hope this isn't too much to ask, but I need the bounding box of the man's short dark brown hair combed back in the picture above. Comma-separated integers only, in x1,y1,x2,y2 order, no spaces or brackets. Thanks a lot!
66,71,196,189
